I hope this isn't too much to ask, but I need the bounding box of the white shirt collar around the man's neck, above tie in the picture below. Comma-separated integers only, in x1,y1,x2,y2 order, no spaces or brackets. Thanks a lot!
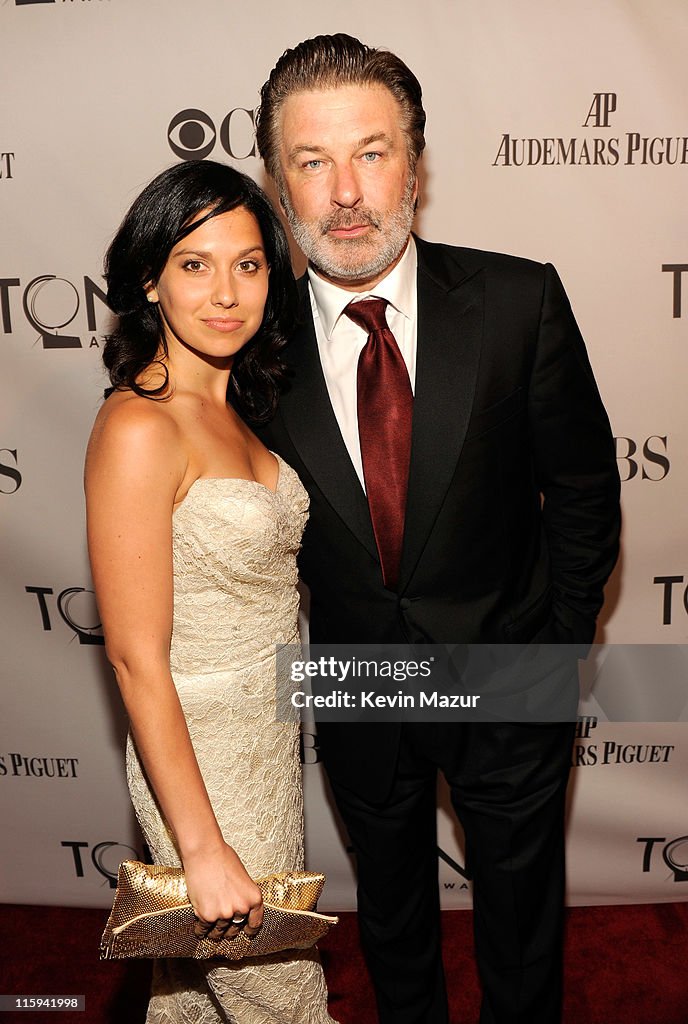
308,236,418,340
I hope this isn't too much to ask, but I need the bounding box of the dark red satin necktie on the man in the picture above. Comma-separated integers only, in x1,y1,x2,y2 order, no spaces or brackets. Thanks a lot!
344,299,414,590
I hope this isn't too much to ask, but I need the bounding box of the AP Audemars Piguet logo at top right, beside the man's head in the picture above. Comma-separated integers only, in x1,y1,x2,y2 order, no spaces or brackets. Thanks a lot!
492,92,688,167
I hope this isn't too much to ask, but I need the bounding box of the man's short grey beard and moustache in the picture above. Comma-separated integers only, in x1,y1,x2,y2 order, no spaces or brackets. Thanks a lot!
280,174,416,282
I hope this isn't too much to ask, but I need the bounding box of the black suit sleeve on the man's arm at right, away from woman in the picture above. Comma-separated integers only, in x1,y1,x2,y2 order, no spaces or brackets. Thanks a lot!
528,264,620,643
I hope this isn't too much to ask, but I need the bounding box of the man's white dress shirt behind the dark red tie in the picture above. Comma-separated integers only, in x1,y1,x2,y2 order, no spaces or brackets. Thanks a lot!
308,238,418,489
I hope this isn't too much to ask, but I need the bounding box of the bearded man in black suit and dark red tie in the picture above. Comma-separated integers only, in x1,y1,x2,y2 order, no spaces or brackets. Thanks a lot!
257,35,619,1024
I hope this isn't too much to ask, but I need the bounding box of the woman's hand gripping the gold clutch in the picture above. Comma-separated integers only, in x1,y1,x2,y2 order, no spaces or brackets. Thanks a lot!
183,842,263,941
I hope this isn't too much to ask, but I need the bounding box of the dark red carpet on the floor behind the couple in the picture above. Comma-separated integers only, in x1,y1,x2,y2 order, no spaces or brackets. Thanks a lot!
0,903,688,1024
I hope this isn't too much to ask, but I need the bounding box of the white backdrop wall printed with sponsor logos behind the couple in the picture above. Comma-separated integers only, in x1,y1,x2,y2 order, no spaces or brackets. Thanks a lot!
0,0,688,909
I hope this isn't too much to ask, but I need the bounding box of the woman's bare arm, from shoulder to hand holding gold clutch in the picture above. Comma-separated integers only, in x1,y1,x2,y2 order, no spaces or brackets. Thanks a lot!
86,398,262,937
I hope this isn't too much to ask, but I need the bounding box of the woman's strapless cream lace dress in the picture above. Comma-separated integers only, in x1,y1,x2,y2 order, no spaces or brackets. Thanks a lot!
127,460,334,1024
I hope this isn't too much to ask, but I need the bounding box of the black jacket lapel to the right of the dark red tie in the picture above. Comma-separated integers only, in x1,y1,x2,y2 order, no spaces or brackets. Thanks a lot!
399,239,484,591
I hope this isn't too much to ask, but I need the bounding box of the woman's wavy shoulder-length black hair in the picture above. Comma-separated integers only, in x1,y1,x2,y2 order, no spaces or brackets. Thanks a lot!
102,160,296,422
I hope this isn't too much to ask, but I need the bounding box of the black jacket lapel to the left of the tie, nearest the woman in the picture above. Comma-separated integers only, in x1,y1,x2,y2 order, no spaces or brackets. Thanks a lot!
280,280,378,559
